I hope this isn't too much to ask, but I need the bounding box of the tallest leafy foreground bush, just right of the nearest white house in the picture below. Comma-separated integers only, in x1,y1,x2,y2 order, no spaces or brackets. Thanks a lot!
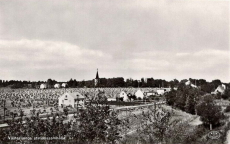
73,100,120,143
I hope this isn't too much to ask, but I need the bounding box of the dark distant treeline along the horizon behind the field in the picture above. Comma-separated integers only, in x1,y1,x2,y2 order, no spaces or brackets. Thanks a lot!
0,77,227,92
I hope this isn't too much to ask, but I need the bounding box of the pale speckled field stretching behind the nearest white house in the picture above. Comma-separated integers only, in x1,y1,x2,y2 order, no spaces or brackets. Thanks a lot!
0,88,165,121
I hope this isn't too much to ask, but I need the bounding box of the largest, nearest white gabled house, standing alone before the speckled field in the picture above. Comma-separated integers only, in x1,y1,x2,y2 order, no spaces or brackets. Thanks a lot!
58,92,85,108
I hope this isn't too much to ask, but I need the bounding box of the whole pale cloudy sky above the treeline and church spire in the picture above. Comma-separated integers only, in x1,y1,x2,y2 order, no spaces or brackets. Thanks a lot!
0,0,230,82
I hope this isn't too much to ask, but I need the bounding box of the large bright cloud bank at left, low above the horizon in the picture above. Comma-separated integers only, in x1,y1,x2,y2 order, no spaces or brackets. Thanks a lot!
0,39,109,79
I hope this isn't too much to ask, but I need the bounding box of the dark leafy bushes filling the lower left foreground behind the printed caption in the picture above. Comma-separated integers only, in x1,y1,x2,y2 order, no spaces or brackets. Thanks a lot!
0,97,120,144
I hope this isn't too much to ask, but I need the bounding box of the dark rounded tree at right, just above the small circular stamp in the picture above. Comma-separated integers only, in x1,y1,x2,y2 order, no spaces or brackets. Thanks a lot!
196,95,224,130
